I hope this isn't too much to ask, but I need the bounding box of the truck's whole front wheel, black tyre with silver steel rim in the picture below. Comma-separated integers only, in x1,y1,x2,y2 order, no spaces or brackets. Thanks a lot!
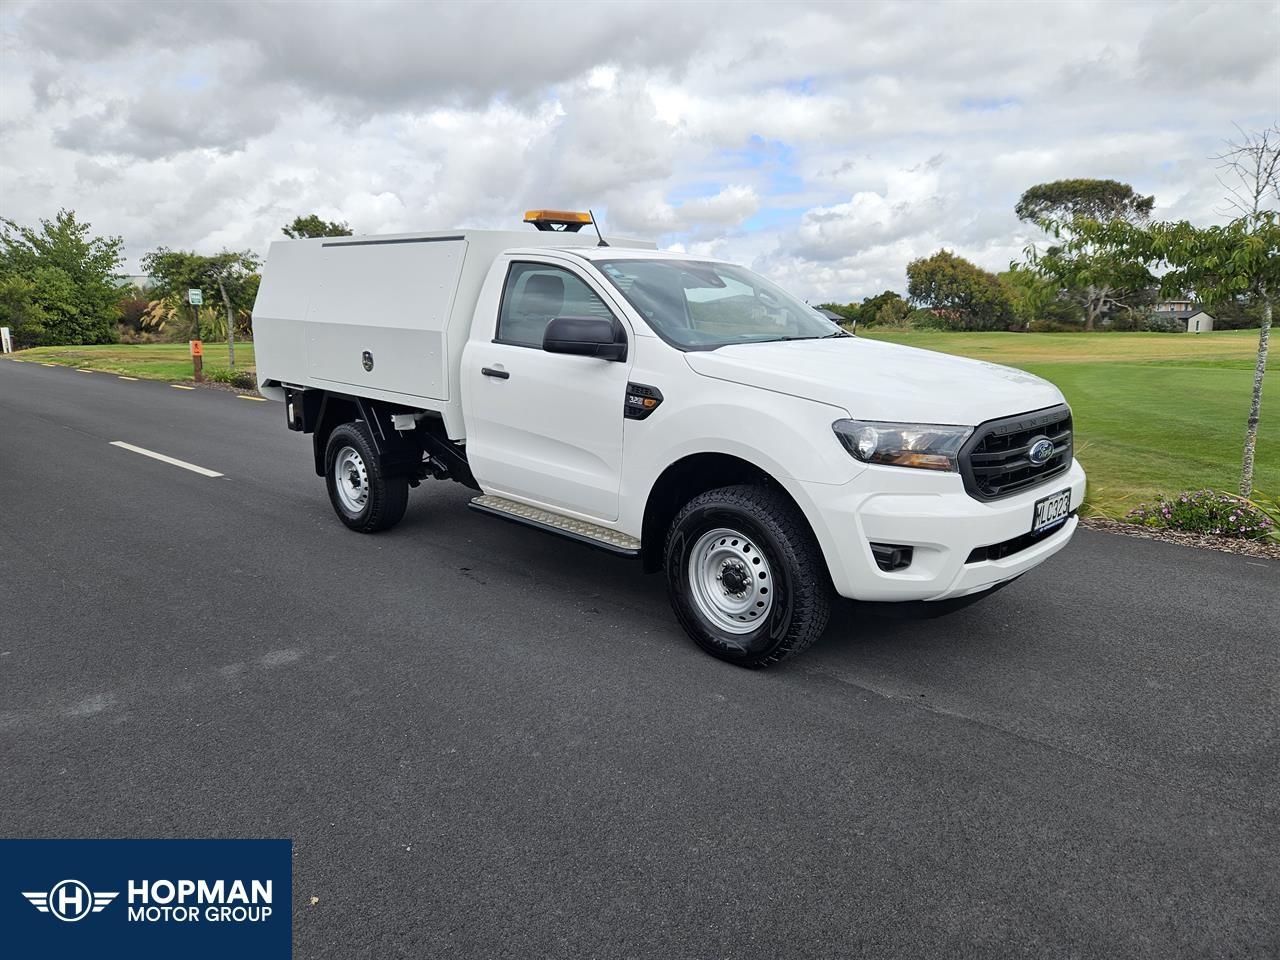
666,484,832,668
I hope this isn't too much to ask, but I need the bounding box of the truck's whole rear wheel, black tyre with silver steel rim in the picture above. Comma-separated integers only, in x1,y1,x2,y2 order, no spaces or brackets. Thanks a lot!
324,420,408,534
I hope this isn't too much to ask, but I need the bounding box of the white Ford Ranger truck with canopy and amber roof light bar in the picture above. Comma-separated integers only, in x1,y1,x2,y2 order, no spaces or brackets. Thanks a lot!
253,211,1084,667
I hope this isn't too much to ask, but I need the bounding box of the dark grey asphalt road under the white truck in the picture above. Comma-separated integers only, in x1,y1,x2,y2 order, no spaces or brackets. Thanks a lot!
0,362,1280,960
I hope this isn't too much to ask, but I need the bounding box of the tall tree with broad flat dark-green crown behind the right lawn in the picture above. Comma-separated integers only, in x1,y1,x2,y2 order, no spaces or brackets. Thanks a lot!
1014,179,1156,330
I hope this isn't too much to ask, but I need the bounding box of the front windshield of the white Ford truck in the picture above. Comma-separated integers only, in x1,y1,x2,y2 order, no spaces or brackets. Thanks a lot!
595,259,847,349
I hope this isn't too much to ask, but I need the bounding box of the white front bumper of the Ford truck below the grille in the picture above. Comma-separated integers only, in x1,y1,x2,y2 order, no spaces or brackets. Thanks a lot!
791,461,1084,602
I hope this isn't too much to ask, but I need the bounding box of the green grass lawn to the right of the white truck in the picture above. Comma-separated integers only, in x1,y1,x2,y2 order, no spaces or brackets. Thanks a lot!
859,329,1280,516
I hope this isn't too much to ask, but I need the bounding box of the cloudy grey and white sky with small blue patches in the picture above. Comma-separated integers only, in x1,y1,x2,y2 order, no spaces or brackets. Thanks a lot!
0,0,1280,301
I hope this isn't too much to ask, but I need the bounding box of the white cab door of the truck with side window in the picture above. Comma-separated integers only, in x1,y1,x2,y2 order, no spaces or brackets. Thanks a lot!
462,256,631,521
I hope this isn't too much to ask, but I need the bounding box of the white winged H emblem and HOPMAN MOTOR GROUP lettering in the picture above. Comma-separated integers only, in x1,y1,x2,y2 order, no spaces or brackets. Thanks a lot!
22,879,271,923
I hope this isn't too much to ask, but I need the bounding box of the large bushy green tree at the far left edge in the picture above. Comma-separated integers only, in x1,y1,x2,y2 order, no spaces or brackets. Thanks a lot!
0,210,123,344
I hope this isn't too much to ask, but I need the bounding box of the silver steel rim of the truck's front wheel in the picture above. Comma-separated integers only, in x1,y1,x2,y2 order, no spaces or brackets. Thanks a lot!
689,527,773,635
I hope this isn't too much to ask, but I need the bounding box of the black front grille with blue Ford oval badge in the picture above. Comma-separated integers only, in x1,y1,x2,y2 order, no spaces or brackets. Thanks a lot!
960,403,1071,500
